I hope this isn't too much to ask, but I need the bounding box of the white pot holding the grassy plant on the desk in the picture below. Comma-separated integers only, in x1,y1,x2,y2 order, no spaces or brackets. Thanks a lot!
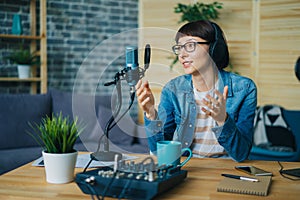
43,151,78,184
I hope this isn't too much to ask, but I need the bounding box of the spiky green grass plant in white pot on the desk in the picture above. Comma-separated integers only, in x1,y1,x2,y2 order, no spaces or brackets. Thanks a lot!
30,113,83,184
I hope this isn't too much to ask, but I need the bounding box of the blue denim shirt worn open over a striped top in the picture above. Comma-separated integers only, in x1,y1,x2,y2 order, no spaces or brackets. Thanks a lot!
144,70,257,162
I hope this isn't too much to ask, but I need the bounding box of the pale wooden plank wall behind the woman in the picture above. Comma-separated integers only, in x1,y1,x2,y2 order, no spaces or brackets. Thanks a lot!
139,0,300,117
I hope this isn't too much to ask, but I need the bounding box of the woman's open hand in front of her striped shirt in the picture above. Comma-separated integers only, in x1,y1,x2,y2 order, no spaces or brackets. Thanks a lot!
201,86,228,126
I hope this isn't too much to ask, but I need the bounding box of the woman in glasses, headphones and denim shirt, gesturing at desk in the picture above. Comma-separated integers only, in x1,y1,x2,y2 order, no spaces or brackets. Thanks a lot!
136,20,257,162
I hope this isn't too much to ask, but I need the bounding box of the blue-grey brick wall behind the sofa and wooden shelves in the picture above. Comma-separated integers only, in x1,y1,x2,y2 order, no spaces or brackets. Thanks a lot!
0,0,138,119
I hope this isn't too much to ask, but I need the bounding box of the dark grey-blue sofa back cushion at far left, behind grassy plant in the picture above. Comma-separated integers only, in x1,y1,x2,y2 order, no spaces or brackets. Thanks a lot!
0,94,51,149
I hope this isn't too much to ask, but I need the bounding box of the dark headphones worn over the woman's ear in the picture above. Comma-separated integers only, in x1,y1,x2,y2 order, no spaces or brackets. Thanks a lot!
209,22,228,67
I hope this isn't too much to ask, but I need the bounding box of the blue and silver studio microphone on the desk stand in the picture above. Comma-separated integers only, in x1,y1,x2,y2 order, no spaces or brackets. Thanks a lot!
126,46,140,93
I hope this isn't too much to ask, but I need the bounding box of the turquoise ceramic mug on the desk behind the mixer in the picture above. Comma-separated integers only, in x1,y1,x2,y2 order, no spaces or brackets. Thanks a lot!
156,141,192,166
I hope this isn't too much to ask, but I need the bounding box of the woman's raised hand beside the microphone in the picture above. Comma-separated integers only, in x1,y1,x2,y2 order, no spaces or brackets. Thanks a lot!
135,80,156,120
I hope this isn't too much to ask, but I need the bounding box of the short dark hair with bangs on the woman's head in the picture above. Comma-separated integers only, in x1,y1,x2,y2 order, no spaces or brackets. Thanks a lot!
175,20,229,69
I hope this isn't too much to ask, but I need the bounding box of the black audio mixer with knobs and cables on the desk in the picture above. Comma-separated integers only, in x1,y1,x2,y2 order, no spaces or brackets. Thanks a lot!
75,157,187,199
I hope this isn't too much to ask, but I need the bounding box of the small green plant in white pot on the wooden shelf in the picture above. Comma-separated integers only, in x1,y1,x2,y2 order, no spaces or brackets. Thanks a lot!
7,48,39,78
